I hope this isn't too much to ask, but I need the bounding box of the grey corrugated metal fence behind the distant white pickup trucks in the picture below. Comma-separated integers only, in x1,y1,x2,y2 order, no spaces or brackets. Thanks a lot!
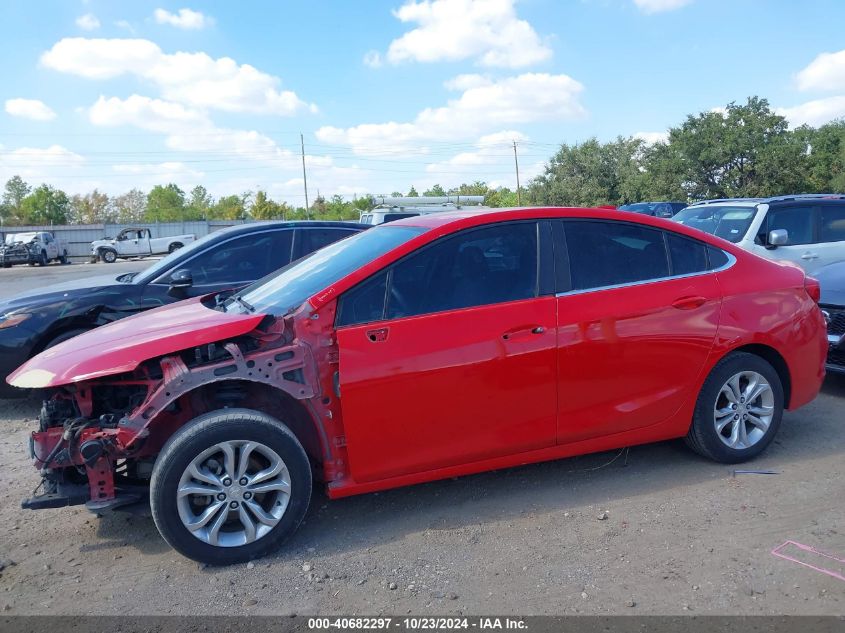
0,220,243,259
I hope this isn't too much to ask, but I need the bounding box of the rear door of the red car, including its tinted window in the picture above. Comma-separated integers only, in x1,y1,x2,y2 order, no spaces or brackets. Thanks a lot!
556,221,722,443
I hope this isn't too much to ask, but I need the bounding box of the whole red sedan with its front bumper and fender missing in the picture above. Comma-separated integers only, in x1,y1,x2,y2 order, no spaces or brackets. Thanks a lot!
9,208,827,564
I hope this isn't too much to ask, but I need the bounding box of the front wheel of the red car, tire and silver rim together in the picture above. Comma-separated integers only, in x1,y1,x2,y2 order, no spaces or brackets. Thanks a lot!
150,409,311,565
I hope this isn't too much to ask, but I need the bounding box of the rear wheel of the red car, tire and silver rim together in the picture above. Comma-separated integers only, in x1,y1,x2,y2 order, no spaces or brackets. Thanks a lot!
686,352,784,464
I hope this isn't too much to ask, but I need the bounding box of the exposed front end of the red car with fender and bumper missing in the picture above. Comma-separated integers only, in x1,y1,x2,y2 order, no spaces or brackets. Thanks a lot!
22,304,345,513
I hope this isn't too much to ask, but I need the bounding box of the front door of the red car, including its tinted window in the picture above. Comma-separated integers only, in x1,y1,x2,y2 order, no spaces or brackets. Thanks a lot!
337,221,557,482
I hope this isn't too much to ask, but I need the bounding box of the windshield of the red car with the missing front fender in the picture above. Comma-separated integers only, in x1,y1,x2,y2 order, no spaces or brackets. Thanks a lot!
226,225,426,315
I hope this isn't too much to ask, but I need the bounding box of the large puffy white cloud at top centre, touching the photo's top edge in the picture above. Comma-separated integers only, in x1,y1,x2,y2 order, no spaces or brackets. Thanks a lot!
380,0,552,68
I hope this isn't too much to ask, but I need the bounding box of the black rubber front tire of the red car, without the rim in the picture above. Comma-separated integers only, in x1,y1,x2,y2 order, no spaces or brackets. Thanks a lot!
150,409,312,565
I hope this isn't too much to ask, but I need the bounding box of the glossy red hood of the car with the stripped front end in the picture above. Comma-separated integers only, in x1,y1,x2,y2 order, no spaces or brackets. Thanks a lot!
6,297,265,389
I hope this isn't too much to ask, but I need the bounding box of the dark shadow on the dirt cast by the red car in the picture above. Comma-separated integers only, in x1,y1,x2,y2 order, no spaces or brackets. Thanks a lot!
38,375,845,562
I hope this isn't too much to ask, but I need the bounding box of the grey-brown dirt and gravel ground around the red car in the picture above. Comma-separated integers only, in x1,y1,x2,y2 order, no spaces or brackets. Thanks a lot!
0,266,845,615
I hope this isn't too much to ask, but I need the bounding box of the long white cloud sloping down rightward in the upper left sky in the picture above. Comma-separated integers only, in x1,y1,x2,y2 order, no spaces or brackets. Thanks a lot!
41,37,317,116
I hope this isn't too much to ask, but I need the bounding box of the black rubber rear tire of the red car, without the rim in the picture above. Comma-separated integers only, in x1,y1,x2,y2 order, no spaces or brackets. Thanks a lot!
685,352,784,464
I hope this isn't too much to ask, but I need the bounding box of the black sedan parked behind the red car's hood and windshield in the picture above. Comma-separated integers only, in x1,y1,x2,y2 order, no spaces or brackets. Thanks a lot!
0,222,370,397
